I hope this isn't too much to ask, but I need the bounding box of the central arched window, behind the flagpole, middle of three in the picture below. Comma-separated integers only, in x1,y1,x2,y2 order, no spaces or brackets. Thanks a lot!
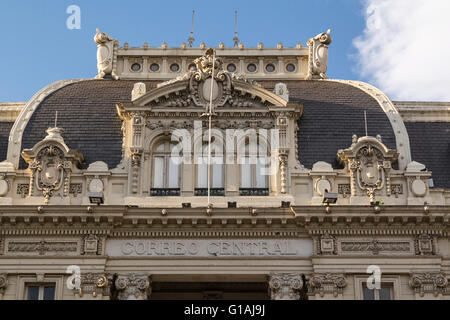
195,144,225,196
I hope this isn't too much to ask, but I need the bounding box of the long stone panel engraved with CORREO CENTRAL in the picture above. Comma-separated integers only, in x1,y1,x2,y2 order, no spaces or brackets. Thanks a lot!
106,239,313,257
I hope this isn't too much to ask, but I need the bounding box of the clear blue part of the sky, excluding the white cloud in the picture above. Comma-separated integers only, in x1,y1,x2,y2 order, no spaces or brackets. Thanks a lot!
0,0,365,101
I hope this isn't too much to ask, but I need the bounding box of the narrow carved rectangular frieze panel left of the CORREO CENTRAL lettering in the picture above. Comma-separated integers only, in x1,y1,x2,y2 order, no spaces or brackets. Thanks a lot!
7,241,78,255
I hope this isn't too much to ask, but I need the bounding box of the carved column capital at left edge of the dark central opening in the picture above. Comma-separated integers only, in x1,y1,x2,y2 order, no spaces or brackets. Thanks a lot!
115,274,151,300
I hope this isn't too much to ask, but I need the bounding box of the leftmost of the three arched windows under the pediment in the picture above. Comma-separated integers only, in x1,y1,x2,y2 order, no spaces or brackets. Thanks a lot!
150,141,182,196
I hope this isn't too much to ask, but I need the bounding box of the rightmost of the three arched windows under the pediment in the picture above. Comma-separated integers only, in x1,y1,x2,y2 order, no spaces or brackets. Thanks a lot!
238,139,270,196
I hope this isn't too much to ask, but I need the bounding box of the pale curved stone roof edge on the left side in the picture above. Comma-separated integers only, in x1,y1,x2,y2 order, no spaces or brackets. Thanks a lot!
6,79,92,169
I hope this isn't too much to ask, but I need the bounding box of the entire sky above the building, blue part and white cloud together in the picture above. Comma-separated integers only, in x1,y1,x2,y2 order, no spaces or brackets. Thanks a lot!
0,0,450,102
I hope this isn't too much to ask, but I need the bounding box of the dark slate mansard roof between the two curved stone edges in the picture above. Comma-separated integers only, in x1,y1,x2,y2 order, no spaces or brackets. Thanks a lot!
16,80,396,174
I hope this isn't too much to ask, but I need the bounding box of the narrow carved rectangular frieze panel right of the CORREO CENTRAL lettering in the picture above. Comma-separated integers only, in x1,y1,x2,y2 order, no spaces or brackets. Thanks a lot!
340,240,412,255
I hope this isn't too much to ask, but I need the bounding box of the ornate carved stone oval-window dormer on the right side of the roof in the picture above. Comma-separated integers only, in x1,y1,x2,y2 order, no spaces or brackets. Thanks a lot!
338,136,398,203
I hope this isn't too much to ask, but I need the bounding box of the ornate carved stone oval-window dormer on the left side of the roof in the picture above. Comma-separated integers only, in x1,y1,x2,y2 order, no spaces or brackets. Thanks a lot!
22,128,83,204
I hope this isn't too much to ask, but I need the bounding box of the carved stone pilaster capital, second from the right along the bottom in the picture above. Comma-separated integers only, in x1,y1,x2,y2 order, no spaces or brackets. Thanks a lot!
308,273,347,297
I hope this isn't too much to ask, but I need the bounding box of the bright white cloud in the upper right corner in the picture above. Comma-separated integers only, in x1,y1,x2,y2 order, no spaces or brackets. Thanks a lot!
353,0,450,101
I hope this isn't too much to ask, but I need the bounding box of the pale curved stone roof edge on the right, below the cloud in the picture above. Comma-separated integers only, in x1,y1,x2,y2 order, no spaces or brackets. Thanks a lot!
324,79,412,170
